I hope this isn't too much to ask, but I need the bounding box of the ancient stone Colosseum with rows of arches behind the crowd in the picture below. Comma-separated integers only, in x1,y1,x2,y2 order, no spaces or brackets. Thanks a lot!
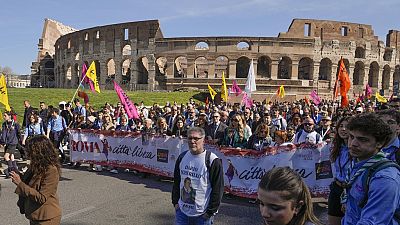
31,19,400,98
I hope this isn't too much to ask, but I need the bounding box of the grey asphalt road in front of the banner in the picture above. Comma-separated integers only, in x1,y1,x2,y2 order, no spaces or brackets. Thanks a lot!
0,161,326,225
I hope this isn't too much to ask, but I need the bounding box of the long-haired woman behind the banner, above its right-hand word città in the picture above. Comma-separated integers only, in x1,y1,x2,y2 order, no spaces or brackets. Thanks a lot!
224,114,251,148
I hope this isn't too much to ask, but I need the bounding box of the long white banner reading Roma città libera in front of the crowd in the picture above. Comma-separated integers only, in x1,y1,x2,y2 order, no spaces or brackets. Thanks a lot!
69,130,334,198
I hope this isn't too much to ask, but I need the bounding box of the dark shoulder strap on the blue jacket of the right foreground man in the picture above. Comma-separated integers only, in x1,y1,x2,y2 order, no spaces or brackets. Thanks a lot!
358,158,400,208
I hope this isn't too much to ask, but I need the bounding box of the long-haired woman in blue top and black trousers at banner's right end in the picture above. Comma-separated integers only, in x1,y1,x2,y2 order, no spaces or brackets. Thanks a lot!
328,117,351,225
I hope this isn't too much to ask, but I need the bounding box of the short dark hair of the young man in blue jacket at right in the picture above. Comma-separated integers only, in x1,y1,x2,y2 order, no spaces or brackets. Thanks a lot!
347,113,393,143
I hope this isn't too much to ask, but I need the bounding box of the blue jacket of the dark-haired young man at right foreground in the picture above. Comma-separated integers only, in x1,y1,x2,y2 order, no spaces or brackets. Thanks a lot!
342,156,400,225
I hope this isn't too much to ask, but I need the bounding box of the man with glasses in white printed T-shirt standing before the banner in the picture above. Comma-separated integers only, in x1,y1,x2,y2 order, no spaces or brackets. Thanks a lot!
172,127,224,225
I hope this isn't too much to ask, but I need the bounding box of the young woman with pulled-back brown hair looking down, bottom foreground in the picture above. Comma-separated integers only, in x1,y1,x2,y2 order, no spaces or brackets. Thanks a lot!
257,167,321,225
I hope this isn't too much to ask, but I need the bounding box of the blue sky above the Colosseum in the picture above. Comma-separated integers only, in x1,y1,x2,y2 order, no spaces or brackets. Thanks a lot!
0,0,400,74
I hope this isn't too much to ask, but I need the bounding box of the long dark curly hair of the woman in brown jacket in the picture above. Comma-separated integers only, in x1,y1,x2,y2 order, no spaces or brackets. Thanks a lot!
26,135,61,177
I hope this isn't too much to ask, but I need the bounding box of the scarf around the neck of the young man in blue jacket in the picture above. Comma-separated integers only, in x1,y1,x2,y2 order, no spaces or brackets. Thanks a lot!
340,151,386,205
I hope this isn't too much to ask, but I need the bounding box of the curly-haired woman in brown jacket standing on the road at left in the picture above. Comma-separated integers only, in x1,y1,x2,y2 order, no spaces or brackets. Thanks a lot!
11,135,61,225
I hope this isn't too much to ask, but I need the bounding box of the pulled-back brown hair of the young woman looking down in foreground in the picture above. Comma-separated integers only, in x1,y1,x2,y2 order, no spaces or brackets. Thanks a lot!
258,167,321,225
